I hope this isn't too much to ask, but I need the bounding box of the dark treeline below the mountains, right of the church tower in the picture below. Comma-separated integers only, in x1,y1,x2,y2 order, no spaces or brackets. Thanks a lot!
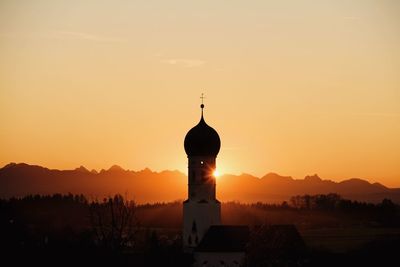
222,194,400,228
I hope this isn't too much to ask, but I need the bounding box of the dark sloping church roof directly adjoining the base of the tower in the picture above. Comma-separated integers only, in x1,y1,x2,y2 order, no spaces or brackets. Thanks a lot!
195,225,250,252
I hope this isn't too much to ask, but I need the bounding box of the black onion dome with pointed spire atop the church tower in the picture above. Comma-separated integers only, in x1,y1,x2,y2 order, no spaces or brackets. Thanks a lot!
184,104,221,157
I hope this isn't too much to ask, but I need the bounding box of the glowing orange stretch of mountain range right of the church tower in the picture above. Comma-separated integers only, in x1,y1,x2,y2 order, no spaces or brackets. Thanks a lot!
217,173,400,203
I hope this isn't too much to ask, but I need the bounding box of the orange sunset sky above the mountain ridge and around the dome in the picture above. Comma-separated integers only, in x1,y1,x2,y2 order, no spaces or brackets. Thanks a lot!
0,0,400,187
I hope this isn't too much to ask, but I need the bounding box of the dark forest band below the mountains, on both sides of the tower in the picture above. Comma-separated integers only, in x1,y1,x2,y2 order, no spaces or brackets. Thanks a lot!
0,194,400,230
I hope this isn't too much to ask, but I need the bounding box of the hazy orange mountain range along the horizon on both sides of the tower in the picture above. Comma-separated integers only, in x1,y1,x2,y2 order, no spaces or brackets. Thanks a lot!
0,163,400,203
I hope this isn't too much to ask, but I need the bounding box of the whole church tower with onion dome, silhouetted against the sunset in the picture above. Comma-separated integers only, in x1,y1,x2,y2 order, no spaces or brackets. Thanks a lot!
183,101,221,252
